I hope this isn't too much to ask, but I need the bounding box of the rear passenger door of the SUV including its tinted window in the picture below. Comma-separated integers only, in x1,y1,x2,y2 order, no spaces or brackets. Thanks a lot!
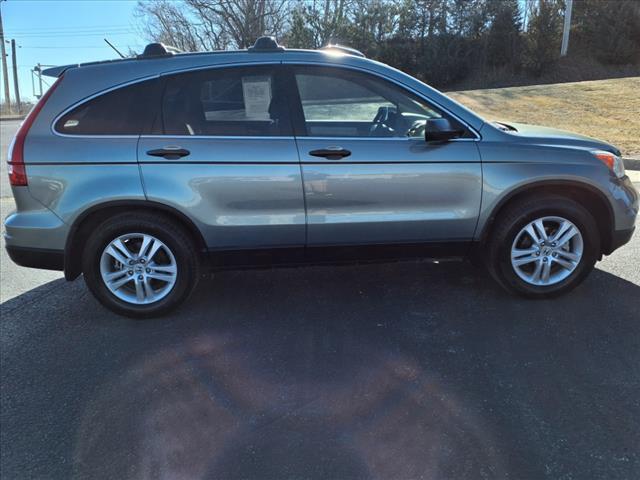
138,65,305,250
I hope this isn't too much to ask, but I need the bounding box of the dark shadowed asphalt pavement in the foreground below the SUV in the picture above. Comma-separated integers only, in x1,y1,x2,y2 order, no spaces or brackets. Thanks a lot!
0,263,640,479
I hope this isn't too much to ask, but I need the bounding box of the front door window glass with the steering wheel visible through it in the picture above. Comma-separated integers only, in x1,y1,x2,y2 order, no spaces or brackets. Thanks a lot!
295,67,464,138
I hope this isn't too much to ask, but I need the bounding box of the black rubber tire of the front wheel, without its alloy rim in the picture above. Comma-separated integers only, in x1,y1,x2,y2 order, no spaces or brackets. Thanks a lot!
490,194,601,299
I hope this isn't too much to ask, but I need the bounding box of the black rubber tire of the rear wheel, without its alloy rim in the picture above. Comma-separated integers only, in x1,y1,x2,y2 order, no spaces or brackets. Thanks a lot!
82,212,199,318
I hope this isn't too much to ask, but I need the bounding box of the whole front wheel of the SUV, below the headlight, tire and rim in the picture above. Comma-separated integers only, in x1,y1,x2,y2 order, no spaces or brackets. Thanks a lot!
486,195,600,298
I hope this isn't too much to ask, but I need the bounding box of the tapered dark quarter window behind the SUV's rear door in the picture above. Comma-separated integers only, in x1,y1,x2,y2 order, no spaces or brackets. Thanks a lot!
55,79,159,135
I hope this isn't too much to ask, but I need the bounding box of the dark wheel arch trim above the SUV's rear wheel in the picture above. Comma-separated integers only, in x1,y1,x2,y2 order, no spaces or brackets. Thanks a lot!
64,200,206,280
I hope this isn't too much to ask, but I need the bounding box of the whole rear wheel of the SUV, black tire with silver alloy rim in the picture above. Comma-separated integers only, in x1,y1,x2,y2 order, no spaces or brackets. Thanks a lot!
83,213,198,318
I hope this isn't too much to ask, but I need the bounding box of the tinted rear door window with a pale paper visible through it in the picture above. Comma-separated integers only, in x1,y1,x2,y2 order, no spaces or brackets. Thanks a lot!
162,66,291,136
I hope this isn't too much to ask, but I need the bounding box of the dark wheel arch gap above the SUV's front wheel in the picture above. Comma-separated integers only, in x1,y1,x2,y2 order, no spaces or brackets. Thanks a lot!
479,180,614,254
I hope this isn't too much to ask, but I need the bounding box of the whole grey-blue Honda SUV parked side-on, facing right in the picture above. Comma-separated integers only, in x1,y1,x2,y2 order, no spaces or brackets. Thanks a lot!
5,38,638,317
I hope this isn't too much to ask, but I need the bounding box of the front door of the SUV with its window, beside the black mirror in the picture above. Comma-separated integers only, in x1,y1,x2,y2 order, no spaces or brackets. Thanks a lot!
291,66,482,246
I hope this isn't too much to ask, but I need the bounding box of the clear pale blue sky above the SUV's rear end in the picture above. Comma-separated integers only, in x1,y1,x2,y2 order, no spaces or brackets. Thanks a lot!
0,0,147,102
